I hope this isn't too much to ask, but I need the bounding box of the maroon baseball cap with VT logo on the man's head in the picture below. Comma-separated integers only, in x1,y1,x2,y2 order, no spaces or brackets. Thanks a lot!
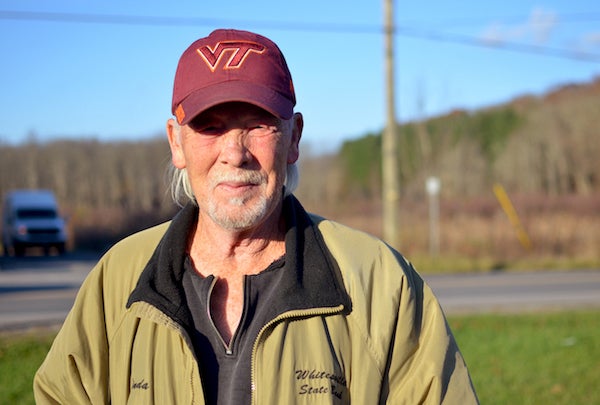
172,29,296,125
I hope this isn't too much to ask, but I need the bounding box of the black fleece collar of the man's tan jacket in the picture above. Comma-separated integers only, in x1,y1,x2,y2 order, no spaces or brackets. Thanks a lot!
127,195,350,328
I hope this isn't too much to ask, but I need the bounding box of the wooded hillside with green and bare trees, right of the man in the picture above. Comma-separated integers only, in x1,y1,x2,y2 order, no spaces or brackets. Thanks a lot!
328,79,600,197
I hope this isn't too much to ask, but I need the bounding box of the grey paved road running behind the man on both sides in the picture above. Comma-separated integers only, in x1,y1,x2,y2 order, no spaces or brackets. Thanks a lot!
0,256,600,331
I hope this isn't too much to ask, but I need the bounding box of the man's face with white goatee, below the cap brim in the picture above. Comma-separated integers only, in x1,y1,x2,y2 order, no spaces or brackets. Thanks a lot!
168,103,301,230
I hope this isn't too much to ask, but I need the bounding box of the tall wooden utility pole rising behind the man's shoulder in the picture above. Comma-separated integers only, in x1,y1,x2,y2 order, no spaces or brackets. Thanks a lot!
381,0,400,246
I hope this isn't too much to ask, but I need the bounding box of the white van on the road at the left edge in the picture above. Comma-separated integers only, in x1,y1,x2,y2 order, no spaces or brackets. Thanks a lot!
2,190,67,256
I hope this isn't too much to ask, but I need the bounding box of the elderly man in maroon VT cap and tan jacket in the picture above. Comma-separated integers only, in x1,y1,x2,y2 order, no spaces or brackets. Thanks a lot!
34,30,477,404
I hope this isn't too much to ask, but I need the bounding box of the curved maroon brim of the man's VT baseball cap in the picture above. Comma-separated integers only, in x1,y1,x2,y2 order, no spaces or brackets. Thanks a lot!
179,81,294,125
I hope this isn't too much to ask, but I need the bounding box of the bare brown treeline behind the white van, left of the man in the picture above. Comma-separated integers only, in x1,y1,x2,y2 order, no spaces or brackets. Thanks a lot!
0,138,175,249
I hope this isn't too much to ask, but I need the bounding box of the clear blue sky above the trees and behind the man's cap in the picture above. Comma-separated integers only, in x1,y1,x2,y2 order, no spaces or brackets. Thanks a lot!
0,0,600,152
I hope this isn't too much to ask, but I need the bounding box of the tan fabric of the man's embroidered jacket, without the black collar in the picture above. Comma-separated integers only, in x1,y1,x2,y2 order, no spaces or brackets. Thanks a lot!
34,196,477,405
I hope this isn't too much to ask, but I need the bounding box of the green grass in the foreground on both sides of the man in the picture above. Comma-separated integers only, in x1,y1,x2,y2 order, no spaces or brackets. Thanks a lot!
0,311,600,405
